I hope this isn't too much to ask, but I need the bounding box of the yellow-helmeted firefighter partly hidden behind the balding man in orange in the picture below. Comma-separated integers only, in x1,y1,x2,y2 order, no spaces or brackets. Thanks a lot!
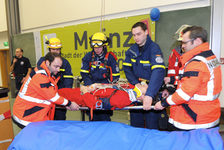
37,38,73,120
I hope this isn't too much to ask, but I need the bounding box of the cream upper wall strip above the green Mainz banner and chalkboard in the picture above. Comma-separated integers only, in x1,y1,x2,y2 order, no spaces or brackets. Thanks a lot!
19,0,210,32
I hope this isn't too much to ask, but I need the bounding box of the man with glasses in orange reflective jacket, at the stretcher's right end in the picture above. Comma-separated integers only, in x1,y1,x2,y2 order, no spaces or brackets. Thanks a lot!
155,26,222,130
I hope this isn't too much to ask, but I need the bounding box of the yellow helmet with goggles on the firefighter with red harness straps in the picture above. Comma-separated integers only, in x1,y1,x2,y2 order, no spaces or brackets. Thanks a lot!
90,32,109,48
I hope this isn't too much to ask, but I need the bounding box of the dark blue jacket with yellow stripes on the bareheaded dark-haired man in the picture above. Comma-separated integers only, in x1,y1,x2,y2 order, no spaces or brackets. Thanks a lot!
123,36,165,97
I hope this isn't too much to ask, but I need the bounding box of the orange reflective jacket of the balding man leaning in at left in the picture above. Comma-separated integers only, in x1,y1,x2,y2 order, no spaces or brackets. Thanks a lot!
13,62,69,126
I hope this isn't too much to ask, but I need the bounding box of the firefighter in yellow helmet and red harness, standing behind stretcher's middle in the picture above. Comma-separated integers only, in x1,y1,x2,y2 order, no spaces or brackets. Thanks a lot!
80,32,120,121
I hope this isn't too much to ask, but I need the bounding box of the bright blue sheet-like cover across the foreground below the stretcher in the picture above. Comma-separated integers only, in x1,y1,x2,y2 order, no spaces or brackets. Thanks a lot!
8,121,224,150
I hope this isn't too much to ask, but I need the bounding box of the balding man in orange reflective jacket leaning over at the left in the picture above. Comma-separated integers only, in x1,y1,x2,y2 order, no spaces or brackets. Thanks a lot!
12,52,79,128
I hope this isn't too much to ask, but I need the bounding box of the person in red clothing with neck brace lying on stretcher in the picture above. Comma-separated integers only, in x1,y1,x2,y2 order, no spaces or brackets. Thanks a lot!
58,83,148,110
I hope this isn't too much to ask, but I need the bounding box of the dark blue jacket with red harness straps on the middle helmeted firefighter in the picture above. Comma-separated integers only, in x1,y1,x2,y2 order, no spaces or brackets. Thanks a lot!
80,50,120,85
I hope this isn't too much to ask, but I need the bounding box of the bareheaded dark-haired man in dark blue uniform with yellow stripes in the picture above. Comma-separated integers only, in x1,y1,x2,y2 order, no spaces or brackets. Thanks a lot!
123,22,165,129
